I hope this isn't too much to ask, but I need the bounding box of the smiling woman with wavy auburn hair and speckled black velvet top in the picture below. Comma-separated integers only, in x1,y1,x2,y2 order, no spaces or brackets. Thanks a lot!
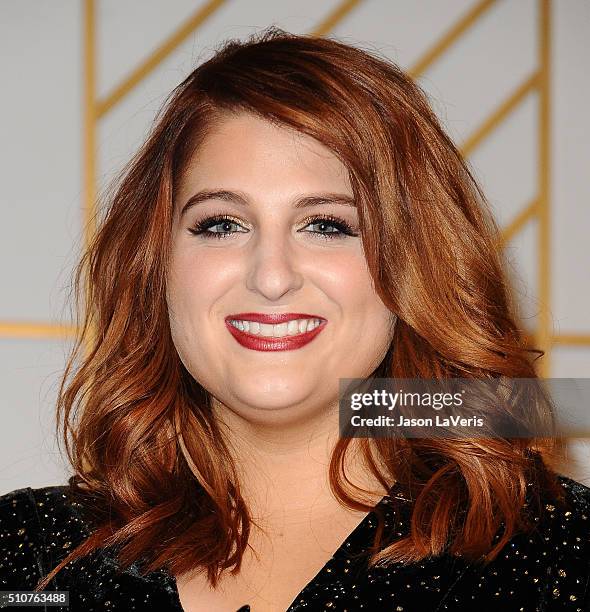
0,28,590,612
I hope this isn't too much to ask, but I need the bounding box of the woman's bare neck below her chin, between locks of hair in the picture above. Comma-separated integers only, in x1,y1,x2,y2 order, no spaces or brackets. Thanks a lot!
216,406,394,525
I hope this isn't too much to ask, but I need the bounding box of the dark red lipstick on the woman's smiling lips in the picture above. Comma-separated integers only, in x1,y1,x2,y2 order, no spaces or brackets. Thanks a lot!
225,312,327,351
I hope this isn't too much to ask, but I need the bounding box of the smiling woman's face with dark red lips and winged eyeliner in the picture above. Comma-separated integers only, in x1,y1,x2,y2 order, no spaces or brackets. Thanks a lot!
167,113,395,422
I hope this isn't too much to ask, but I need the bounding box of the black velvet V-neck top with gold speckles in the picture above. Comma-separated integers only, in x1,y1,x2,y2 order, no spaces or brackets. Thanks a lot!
0,475,590,612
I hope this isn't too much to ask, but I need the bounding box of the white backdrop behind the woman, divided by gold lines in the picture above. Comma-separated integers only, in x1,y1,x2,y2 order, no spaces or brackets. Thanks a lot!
0,0,590,493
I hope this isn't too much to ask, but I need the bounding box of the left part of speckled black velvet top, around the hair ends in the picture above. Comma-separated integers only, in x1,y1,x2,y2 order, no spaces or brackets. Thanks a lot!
0,485,178,610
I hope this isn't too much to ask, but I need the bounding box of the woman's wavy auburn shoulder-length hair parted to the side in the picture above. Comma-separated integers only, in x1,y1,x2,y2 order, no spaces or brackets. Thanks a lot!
37,27,560,589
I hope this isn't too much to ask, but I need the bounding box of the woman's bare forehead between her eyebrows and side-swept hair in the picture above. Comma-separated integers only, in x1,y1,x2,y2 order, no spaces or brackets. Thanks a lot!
179,112,352,193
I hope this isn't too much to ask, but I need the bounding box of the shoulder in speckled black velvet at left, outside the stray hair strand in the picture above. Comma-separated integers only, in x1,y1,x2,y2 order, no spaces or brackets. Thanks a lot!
0,485,85,590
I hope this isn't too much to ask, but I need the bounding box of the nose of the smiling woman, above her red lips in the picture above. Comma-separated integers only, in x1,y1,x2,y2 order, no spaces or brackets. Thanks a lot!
244,232,303,301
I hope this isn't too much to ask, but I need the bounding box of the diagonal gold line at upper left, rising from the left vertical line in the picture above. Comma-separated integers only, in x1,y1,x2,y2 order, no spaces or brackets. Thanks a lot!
96,0,227,118
